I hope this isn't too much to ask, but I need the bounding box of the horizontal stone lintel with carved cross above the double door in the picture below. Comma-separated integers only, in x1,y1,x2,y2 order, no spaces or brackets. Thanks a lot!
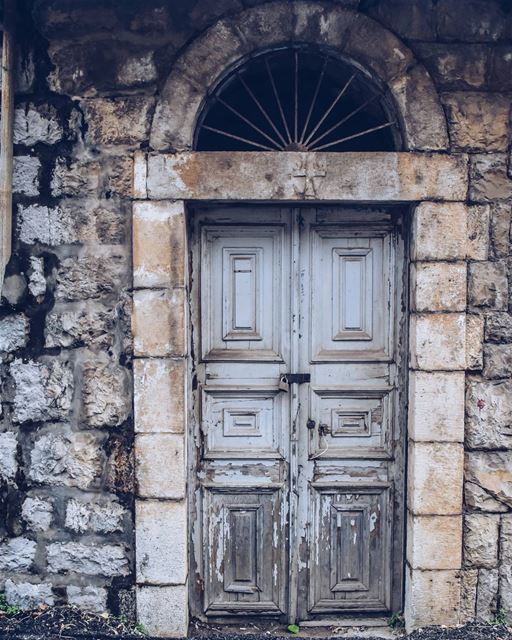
135,151,468,202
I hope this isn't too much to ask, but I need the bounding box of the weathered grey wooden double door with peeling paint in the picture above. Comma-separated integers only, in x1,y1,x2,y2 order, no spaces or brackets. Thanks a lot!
189,207,405,621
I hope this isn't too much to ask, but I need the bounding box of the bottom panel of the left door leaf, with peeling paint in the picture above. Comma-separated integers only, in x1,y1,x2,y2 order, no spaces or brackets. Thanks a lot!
203,487,286,616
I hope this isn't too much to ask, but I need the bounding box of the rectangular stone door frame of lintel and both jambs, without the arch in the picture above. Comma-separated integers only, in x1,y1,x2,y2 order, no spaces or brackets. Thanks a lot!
133,152,485,636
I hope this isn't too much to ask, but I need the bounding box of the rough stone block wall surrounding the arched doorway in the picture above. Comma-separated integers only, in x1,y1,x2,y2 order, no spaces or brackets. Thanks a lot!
0,0,512,620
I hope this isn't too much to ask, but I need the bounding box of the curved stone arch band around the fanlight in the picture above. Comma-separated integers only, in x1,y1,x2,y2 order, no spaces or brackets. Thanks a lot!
150,0,448,151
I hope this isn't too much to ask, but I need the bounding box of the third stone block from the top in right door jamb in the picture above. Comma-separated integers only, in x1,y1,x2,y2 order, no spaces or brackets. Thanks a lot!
410,313,466,371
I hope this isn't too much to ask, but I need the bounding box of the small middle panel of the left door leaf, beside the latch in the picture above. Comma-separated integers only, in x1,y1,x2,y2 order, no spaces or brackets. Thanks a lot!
202,387,286,459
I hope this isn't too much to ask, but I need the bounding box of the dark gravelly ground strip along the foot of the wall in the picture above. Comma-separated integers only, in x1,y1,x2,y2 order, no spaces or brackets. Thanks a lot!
0,606,512,640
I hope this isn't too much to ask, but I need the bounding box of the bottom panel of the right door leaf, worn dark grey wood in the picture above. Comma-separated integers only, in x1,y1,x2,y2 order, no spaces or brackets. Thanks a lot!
310,485,391,613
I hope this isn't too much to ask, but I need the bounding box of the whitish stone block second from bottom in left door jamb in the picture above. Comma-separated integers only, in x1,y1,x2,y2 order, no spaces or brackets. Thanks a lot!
135,500,188,585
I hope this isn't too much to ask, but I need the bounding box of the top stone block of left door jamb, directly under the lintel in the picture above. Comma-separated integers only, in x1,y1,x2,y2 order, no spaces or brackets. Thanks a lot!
133,201,187,287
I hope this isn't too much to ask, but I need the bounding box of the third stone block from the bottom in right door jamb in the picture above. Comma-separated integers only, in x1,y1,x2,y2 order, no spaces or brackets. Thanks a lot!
407,442,464,516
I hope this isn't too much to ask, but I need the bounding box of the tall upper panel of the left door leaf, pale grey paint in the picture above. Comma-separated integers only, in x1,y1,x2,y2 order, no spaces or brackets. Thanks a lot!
200,225,289,362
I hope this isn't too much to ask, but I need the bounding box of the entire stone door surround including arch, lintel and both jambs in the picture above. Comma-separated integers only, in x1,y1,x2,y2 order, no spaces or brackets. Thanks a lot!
132,0,488,636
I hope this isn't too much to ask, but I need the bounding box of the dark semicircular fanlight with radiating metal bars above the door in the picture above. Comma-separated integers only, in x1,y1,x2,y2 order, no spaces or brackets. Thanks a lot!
195,47,401,151
